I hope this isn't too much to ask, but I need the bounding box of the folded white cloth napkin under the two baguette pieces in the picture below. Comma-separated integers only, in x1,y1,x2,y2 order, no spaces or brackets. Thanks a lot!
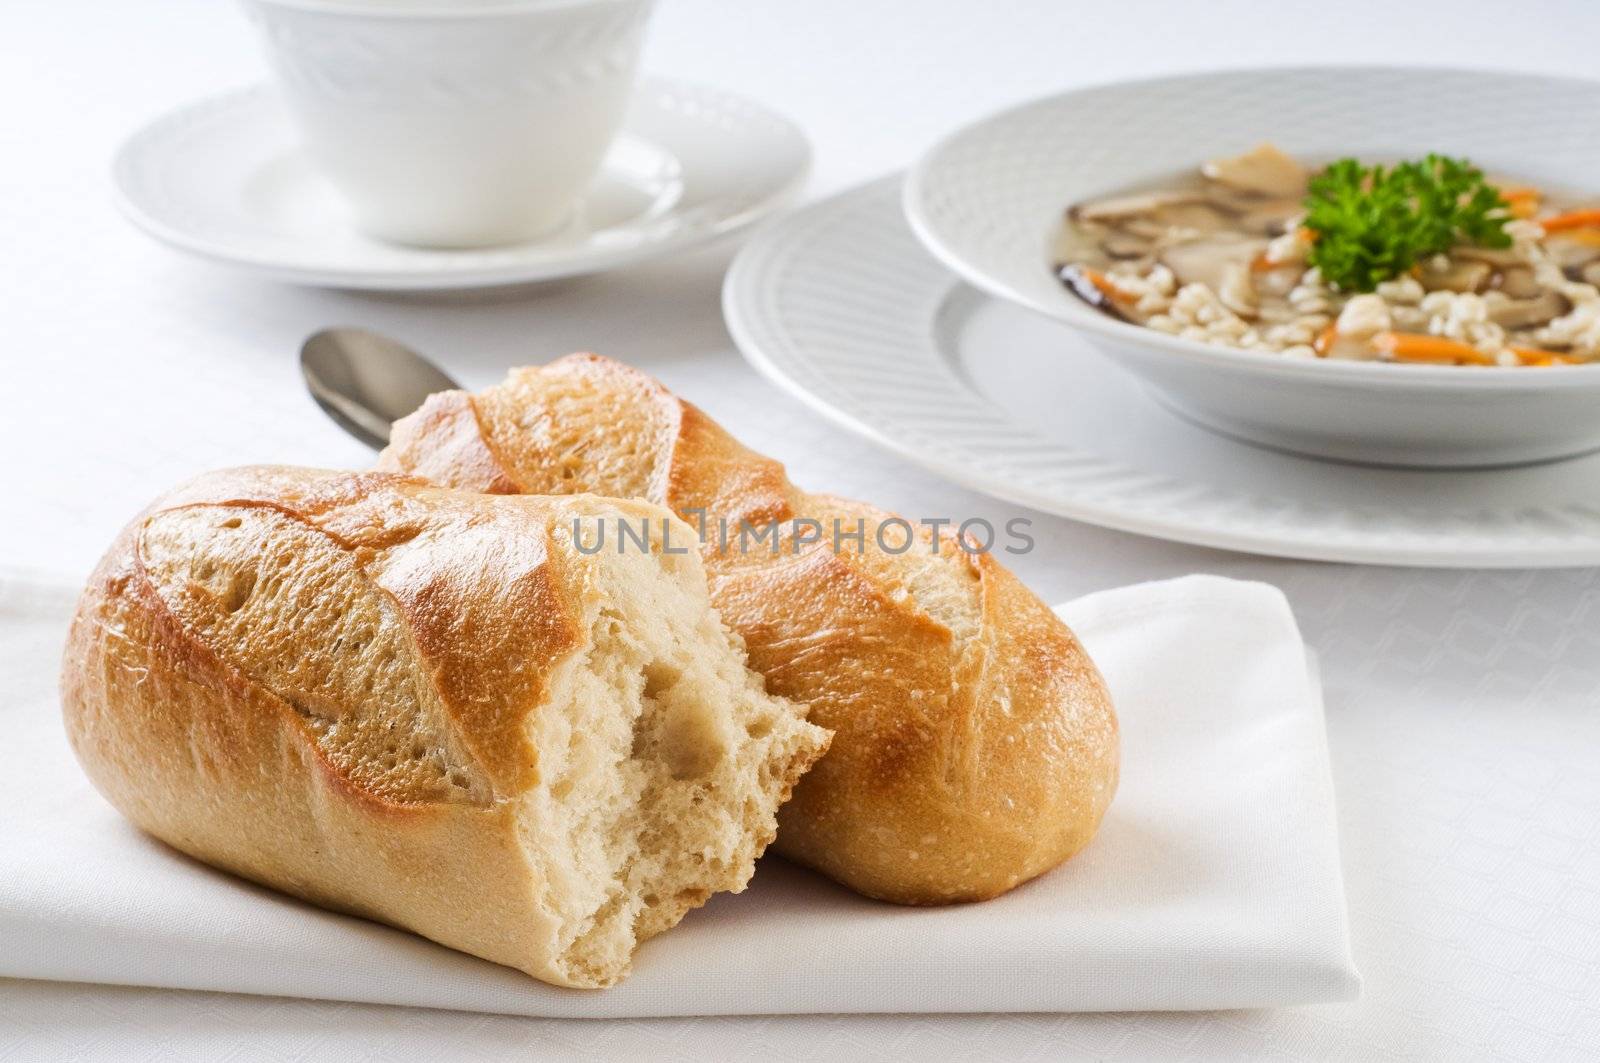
0,575,1360,1018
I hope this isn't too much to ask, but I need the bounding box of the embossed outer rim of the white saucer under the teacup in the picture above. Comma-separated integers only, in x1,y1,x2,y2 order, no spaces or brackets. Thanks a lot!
112,77,811,291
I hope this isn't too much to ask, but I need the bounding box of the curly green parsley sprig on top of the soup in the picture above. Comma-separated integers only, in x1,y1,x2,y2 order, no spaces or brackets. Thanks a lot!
1304,155,1510,291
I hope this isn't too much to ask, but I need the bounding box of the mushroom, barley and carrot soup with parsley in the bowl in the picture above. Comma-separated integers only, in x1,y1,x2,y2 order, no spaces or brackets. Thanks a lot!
1054,144,1600,367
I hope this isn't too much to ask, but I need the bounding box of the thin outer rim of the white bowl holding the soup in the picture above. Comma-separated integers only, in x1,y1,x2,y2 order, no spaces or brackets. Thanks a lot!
901,62,1600,391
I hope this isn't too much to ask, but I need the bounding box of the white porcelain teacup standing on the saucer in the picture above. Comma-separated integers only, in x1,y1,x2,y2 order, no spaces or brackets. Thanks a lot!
245,0,653,247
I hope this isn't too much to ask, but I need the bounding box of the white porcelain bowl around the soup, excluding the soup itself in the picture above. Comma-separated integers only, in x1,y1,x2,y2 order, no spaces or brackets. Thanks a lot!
904,67,1600,467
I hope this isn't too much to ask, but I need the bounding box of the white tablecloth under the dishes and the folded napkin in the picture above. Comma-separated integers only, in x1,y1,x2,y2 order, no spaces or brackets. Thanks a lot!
0,0,1600,1060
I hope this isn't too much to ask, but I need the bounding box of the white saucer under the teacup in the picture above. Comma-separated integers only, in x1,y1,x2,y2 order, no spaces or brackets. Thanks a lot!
112,80,811,290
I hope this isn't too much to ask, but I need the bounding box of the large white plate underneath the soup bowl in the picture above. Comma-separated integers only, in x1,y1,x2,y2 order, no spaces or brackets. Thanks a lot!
723,178,1600,568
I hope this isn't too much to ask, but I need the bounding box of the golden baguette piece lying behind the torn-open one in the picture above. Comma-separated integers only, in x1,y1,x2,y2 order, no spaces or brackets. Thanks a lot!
379,355,1118,905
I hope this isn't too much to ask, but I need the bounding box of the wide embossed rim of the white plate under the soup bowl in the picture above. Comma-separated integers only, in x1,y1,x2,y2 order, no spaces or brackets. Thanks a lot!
723,174,1600,568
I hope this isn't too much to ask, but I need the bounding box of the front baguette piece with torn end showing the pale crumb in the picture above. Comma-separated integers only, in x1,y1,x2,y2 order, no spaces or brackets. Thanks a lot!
61,467,827,986
